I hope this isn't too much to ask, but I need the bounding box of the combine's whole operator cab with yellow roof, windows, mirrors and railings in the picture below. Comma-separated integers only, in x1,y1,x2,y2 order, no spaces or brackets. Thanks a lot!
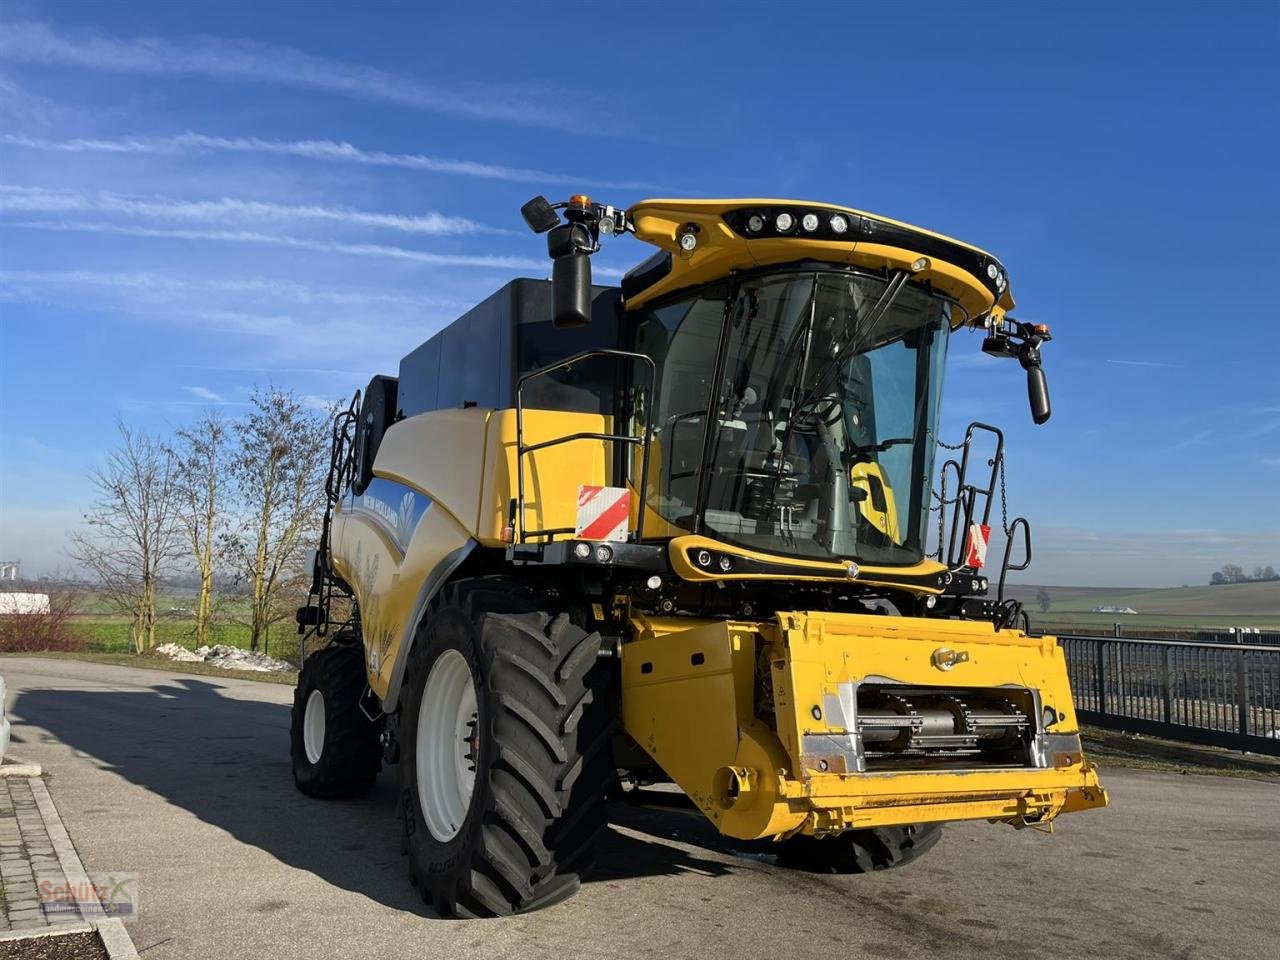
494,196,1050,620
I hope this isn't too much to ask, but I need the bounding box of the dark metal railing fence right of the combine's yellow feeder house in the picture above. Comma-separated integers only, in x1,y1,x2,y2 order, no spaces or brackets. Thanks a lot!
1059,636,1280,756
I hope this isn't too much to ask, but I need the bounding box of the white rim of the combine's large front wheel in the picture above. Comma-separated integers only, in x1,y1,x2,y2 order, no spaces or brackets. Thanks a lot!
415,650,480,844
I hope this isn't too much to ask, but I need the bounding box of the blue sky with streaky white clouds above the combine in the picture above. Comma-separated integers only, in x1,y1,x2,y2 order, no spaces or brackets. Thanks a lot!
0,0,1280,585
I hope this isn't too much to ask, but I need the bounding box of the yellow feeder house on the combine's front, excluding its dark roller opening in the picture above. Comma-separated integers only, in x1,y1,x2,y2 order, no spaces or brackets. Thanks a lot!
622,612,1106,838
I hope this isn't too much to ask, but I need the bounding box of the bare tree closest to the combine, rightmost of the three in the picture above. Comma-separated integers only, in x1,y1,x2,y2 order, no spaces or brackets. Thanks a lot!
225,387,329,650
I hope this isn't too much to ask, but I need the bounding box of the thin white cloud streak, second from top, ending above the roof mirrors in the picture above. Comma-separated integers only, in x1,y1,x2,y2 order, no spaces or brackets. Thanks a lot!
0,132,659,191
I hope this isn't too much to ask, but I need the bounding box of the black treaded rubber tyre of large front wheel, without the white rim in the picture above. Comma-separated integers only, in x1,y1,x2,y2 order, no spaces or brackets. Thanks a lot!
401,577,616,916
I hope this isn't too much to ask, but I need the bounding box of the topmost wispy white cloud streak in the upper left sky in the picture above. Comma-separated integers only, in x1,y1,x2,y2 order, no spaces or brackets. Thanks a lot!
0,20,580,128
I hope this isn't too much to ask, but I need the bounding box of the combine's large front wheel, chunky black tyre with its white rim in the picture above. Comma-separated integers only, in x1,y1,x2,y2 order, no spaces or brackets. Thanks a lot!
399,580,614,916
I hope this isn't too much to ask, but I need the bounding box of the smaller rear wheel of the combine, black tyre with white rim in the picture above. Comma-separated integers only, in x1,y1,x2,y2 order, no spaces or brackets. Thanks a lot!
289,644,381,799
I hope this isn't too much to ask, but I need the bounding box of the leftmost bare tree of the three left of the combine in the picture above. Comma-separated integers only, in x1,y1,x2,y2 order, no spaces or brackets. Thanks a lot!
70,421,180,653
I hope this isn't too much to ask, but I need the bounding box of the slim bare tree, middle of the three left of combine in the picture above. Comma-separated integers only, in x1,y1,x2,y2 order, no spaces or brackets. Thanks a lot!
173,410,229,646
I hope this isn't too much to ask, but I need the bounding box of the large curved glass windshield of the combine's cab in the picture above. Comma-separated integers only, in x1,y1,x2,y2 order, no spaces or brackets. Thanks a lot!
636,269,959,564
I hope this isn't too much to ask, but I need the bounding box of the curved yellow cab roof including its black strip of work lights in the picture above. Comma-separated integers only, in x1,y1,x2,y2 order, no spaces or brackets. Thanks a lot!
622,198,1014,324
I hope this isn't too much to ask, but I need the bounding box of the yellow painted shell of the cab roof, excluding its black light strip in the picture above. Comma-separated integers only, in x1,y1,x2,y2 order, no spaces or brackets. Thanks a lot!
627,198,1014,317
